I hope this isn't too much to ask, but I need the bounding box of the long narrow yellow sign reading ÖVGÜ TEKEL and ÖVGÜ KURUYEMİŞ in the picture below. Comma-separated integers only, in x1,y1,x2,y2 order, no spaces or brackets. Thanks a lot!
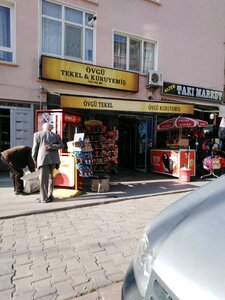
60,95,194,114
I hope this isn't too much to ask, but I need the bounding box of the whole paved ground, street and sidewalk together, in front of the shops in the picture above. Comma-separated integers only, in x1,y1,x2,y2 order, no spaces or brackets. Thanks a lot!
0,172,215,300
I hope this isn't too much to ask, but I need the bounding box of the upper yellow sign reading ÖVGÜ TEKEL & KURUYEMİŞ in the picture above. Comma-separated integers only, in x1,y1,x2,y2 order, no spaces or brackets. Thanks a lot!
41,56,139,92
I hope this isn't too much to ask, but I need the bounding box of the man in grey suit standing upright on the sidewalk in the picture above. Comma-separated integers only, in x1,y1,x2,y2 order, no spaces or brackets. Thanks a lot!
32,123,64,203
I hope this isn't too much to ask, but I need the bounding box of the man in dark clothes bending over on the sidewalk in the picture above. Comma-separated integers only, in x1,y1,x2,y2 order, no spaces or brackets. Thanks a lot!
1,146,35,195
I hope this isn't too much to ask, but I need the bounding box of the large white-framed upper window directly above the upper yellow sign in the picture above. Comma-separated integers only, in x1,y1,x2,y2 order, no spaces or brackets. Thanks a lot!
42,0,94,62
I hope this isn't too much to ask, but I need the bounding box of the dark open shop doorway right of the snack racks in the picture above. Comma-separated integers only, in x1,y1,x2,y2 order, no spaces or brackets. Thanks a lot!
118,117,153,172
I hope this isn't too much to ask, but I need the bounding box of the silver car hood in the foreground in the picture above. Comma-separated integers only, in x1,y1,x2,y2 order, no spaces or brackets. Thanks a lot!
147,176,225,300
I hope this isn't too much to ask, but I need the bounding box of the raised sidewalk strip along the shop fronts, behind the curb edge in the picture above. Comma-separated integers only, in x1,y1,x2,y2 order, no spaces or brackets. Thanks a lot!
0,171,212,219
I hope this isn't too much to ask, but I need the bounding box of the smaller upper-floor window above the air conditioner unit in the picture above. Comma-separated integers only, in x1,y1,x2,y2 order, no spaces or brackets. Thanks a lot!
113,33,156,73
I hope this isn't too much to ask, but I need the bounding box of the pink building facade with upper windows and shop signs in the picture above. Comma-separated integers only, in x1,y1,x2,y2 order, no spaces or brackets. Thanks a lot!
0,0,225,171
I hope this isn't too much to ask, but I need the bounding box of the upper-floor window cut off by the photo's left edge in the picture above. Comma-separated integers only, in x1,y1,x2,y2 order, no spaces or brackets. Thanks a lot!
0,0,15,62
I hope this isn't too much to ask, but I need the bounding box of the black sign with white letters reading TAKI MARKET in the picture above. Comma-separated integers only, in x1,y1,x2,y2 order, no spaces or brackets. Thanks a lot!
163,82,223,101
